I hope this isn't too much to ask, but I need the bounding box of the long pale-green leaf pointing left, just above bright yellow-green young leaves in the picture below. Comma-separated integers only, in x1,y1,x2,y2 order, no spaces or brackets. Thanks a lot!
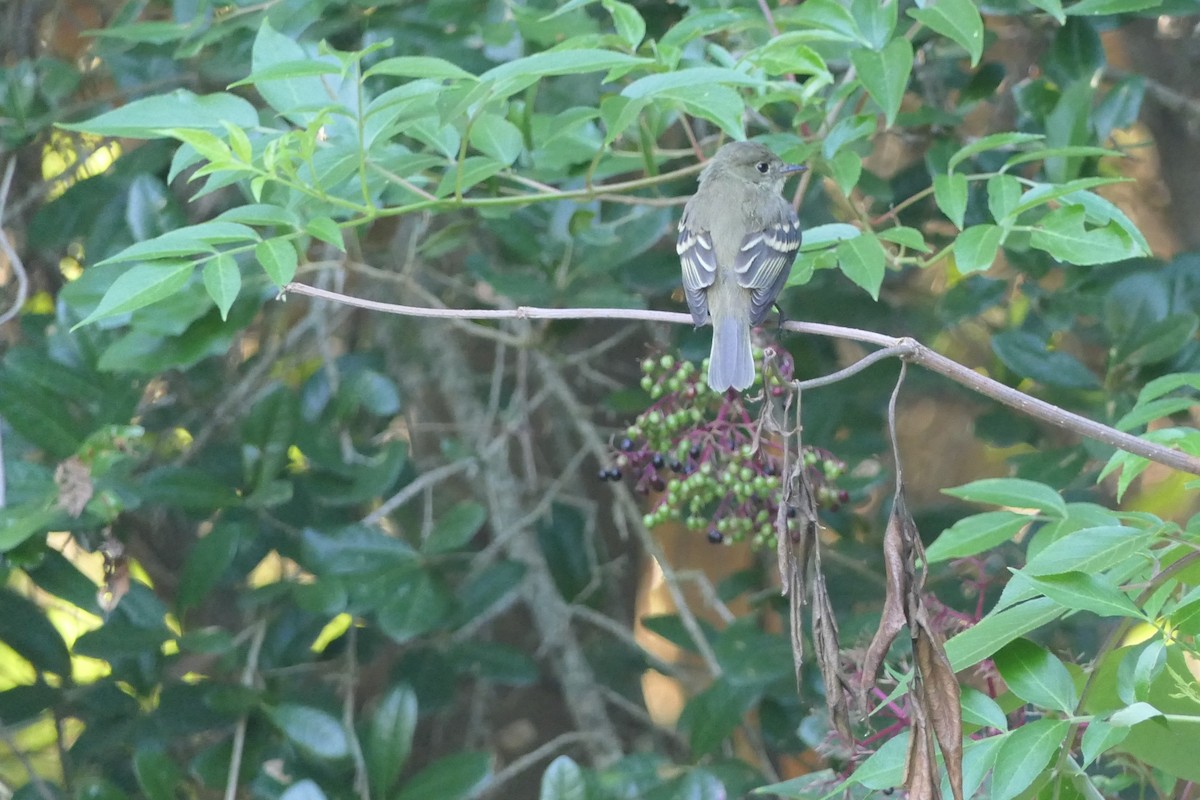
59,89,258,139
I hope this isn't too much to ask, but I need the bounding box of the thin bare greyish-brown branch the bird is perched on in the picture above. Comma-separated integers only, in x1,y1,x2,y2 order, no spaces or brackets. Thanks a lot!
284,283,1200,475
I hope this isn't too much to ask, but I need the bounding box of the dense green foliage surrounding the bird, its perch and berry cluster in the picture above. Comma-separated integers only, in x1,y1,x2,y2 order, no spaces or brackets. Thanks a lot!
0,0,1200,800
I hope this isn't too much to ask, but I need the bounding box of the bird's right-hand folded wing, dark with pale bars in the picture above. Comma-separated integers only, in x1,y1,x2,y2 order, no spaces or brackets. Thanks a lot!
733,197,800,325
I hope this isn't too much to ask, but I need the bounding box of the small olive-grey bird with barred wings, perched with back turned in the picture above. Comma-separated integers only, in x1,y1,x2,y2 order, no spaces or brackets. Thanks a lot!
676,142,806,392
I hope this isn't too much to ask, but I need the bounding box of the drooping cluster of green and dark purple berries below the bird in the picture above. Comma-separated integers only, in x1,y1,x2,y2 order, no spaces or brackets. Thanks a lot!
599,348,850,547
